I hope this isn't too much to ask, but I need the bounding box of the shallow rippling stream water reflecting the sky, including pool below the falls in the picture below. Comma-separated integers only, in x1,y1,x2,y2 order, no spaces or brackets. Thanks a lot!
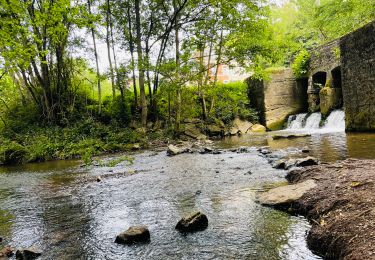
0,110,375,260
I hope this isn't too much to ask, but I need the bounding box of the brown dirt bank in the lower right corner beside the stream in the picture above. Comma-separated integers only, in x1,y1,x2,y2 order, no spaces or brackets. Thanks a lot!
287,159,375,260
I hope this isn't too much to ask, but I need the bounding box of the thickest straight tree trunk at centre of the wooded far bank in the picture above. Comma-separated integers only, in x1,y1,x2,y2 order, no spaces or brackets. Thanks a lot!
134,0,147,128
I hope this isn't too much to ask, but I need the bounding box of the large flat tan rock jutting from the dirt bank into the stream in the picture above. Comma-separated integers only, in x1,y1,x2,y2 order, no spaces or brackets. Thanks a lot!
258,180,317,206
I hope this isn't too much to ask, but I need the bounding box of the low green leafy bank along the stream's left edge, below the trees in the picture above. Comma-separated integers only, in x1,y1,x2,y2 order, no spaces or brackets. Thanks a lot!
0,119,169,164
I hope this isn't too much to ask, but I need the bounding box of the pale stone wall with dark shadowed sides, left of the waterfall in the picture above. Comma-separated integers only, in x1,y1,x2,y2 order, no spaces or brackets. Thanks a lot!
248,69,307,130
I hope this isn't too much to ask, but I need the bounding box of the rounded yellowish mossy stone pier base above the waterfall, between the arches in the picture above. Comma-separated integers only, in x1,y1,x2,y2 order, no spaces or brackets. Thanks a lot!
319,87,342,116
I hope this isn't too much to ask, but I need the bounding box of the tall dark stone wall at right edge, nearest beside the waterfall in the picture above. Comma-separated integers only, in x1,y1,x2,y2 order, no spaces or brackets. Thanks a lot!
340,21,375,131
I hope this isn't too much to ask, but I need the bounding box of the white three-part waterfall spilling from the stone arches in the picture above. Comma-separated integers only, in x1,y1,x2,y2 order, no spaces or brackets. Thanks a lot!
286,110,345,132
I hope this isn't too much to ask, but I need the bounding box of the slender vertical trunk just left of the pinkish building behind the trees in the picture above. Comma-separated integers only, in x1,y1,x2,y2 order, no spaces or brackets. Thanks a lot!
174,2,181,135
